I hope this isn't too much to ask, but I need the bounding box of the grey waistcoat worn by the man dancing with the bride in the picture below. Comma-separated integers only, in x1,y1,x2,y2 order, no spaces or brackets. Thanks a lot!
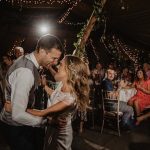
0,56,39,126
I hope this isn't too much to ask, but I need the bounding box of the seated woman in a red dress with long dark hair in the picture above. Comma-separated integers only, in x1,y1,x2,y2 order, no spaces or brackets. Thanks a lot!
128,69,150,116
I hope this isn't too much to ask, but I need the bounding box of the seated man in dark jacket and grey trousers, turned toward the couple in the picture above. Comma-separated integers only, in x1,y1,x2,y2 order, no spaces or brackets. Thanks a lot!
102,69,134,128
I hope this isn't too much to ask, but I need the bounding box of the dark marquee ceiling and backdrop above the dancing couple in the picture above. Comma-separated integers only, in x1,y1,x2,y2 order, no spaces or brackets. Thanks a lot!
0,0,150,66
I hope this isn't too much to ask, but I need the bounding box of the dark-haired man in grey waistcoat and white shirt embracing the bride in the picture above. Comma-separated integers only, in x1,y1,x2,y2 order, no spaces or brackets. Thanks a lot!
1,34,63,150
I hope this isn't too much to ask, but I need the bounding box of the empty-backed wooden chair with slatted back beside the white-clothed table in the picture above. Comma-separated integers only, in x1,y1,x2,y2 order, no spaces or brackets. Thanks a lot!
101,90,123,136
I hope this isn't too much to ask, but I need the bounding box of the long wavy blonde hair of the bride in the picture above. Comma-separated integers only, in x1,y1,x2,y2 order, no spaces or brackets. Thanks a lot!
64,55,90,111
